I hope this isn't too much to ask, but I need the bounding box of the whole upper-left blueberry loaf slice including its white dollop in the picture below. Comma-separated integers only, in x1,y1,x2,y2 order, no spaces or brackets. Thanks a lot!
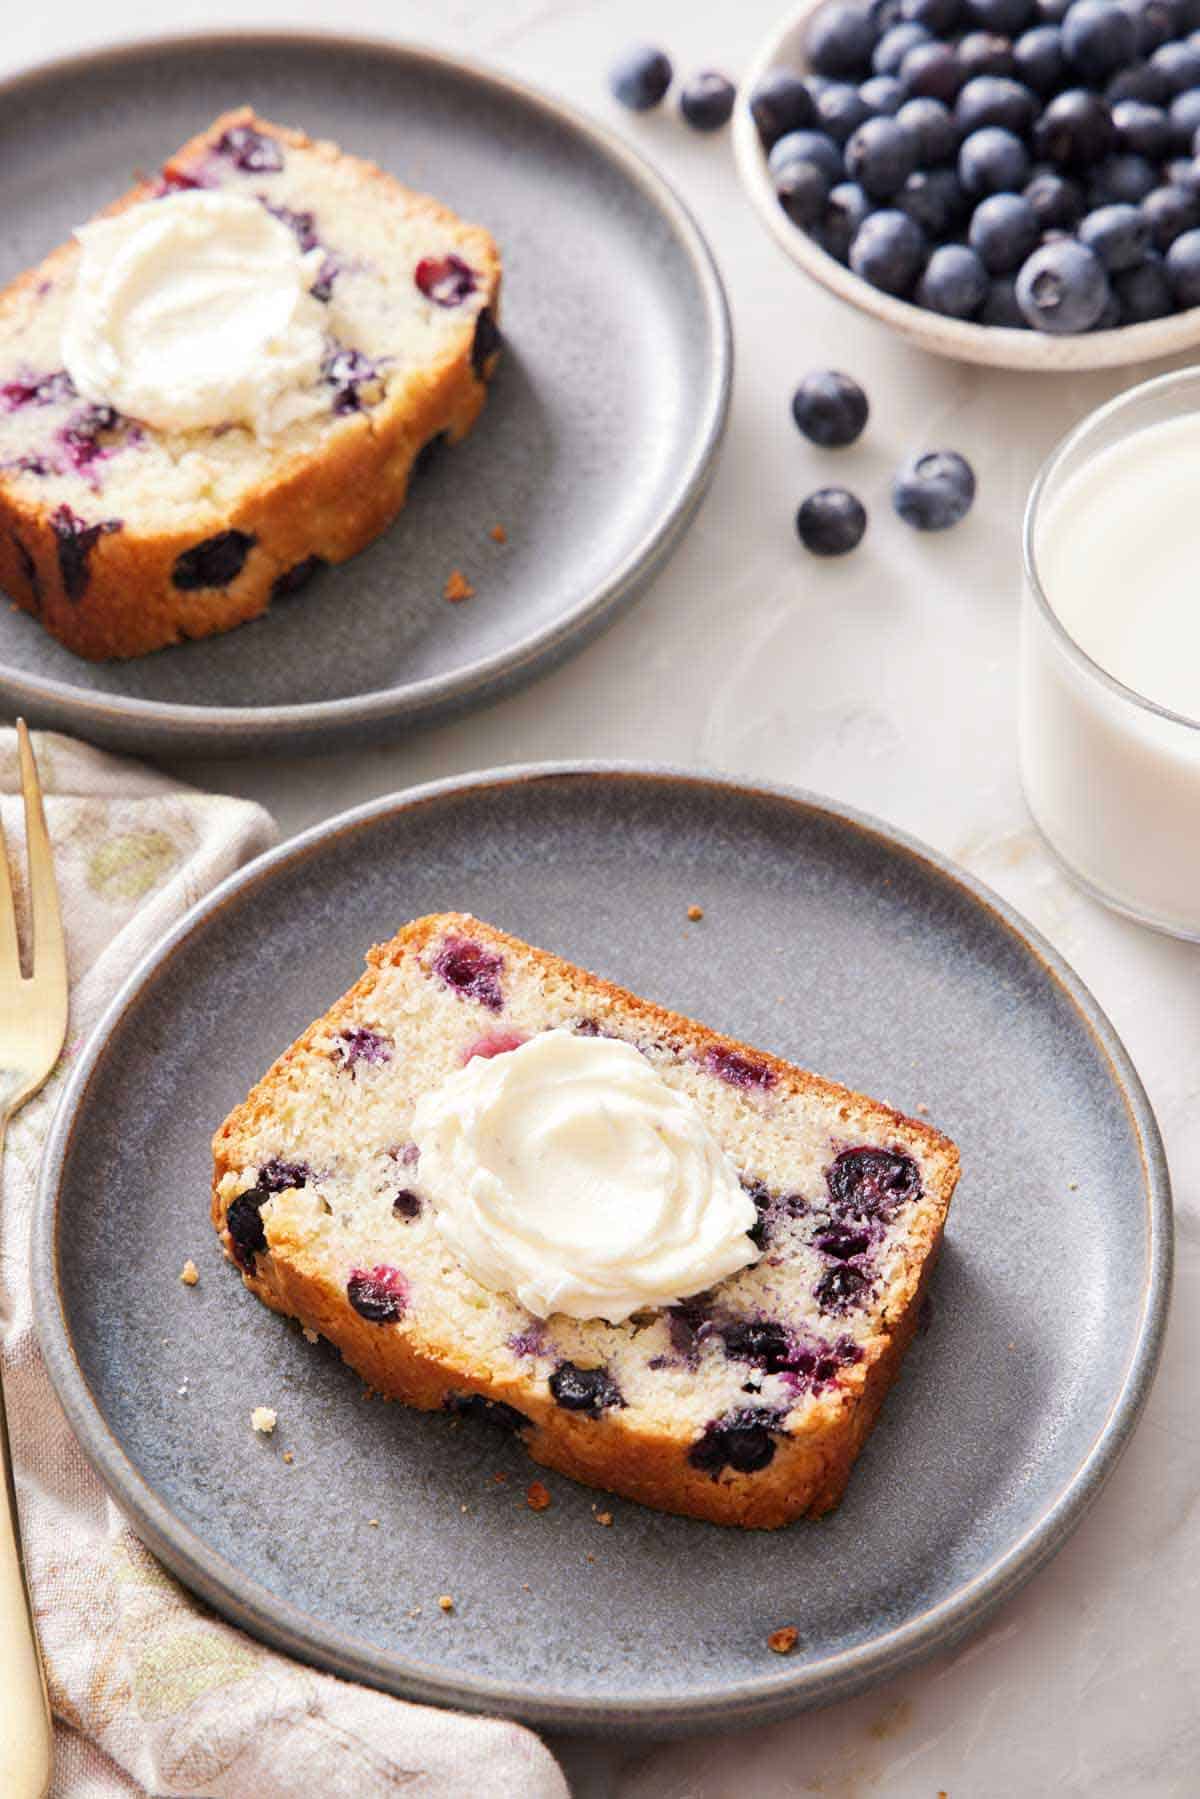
0,108,500,660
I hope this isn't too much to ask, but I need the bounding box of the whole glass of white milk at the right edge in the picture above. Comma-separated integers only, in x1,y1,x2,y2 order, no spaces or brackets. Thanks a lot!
1020,369,1200,939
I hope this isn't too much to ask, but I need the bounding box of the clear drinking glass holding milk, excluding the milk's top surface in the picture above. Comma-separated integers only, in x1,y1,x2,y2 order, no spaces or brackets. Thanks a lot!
1020,369,1200,939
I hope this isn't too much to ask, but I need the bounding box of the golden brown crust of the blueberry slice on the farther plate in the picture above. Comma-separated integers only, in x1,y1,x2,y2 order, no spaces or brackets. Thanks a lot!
0,106,500,662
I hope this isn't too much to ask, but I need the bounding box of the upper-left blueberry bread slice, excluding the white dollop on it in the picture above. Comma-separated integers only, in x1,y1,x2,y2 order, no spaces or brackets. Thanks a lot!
0,108,500,660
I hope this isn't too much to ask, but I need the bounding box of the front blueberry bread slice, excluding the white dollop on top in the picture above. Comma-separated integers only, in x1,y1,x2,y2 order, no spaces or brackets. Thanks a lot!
212,914,959,1527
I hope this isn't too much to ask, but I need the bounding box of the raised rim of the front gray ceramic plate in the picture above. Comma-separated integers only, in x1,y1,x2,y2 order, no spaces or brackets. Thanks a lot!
31,759,1173,1736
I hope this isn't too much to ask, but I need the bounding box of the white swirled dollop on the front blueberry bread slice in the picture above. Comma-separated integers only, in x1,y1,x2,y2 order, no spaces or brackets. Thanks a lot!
412,1031,757,1324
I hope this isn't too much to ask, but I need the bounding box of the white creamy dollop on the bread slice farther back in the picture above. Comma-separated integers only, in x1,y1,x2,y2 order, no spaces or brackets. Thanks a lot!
63,189,327,437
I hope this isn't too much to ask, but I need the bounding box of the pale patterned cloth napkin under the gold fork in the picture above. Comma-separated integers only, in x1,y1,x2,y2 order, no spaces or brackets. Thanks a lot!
0,729,567,1799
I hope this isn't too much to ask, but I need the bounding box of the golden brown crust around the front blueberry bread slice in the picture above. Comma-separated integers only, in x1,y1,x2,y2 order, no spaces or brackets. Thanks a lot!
212,912,959,1529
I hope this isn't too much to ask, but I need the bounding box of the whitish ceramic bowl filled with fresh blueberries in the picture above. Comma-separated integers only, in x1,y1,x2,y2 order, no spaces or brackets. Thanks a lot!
734,0,1200,371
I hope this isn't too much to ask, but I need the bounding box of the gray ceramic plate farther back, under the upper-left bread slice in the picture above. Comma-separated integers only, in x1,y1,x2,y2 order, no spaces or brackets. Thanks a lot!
0,32,732,756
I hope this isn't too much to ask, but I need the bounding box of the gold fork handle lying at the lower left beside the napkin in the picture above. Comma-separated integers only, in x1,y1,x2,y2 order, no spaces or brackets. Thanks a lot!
0,1383,54,1799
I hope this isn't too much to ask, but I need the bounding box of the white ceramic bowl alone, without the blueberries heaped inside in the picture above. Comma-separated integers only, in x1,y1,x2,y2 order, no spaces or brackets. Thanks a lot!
734,0,1200,372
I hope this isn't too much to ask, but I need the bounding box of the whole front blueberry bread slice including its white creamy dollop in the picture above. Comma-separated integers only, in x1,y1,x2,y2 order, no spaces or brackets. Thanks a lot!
212,914,959,1527
